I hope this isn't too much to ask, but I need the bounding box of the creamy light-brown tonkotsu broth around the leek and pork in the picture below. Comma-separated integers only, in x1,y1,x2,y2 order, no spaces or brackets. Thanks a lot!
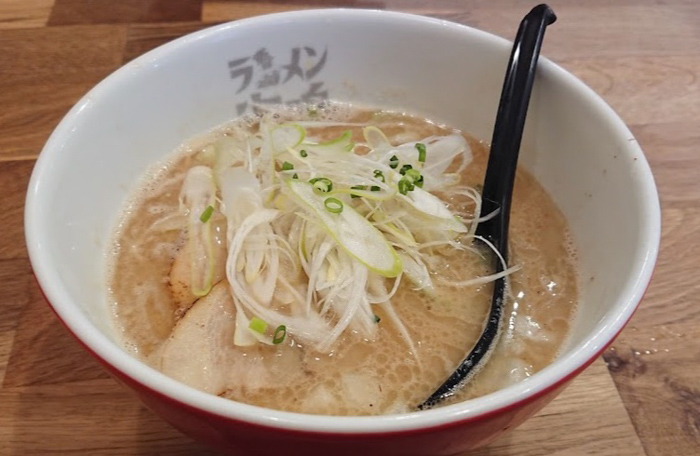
109,105,578,415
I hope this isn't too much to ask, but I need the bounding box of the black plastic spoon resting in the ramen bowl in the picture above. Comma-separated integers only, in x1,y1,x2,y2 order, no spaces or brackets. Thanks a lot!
418,4,557,409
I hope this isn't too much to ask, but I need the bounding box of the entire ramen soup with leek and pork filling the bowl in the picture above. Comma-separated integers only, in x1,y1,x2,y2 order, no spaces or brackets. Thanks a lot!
110,104,577,415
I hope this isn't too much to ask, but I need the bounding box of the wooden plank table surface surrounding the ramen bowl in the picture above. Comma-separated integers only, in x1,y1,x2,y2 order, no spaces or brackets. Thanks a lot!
0,0,700,456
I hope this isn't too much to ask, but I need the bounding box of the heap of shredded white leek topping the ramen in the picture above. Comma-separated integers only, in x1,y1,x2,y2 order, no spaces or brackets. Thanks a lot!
175,114,515,356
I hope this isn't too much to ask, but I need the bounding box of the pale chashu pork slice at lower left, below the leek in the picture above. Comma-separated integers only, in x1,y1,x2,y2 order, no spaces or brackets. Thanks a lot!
157,280,236,395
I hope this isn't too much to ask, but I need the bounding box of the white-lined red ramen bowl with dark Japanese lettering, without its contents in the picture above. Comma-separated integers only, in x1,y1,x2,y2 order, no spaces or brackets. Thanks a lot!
26,10,660,456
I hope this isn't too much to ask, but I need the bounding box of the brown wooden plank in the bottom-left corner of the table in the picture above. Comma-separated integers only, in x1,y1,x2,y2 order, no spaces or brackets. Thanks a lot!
0,378,214,456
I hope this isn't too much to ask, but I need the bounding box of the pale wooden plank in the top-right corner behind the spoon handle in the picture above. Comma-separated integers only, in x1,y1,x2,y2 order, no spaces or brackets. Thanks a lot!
434,0,700,61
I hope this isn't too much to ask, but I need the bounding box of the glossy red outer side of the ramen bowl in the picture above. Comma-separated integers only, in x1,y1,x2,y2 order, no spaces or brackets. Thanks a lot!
40,276,629,456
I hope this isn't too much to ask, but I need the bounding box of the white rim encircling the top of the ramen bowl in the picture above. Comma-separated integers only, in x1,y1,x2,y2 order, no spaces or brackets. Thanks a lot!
25,8,660,435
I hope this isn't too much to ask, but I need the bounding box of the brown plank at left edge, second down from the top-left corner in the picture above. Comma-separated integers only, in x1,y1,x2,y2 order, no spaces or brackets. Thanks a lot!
0,26,126,160
